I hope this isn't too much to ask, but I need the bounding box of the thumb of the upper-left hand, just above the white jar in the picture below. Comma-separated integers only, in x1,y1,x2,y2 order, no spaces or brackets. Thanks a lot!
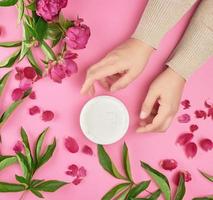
110,72,136,92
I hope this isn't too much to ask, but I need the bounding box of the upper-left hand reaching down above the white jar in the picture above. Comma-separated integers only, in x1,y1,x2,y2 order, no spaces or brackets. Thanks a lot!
81,38,154,95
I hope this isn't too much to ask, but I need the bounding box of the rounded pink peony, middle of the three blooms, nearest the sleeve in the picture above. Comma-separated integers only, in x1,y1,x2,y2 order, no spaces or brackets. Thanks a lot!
65,23,91,49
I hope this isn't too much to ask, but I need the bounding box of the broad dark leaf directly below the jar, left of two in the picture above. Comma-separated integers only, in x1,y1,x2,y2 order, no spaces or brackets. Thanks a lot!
98,145,126,180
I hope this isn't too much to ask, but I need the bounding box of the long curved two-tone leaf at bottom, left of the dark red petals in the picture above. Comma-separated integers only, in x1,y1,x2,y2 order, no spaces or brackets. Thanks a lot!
141,162,171,200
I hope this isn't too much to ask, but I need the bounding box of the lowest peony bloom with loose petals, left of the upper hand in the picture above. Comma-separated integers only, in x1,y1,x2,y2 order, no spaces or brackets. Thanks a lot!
48,51,78,83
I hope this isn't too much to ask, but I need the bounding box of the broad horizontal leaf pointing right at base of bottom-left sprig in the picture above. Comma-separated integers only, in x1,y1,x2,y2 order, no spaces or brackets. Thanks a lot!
34,180,68,192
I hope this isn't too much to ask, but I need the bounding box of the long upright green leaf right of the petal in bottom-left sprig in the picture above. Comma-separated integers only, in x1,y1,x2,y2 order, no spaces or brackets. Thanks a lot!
21,127,34,171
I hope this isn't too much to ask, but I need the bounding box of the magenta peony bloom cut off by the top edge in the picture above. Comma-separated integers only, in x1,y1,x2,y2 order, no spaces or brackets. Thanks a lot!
36,0,68,21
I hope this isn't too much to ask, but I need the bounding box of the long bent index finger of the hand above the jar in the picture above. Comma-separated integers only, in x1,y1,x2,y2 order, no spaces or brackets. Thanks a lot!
81,64,121,94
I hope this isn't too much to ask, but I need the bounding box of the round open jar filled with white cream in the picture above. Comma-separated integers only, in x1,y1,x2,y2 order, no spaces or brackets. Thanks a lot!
80,96,129,144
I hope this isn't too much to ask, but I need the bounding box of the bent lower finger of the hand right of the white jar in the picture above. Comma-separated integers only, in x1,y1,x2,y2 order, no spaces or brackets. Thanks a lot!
137,106,171,133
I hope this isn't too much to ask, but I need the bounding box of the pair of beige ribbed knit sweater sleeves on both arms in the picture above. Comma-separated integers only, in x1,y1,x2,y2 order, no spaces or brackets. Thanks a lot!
133,0,213,79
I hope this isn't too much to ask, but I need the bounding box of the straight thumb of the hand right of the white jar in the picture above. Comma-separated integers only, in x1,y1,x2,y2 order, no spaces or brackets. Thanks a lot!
140,88,159,119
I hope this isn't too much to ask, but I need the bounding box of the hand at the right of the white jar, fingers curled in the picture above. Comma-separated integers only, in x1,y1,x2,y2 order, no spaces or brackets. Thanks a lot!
137,68,185,133
